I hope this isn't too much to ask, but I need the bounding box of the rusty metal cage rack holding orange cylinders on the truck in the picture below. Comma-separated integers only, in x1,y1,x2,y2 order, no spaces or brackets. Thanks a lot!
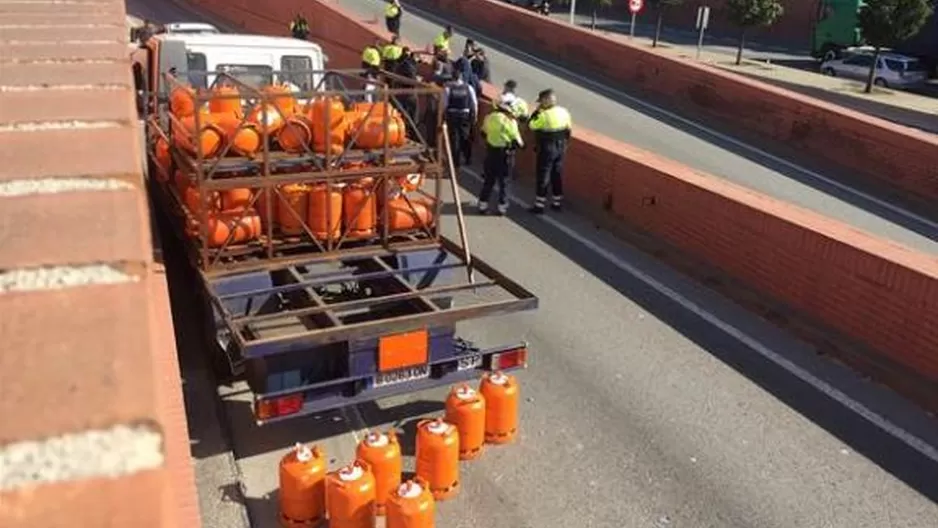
146,70,458,273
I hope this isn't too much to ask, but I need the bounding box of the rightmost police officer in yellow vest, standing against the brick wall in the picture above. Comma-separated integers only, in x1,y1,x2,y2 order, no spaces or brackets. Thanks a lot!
528,90,573,214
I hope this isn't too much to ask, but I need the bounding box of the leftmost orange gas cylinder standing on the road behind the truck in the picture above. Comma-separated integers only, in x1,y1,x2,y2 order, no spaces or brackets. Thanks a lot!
280,443,328,528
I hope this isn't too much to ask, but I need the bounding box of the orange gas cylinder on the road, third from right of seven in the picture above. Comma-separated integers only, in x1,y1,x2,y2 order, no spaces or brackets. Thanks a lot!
416,418,459,500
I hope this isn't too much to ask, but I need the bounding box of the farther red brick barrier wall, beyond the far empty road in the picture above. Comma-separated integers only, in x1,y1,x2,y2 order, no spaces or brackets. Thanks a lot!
405,0,938,203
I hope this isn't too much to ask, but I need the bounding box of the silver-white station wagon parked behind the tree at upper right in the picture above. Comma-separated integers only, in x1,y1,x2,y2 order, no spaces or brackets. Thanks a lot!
821,50,928,88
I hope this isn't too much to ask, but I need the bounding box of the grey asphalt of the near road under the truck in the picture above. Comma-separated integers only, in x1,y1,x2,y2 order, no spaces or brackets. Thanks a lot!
128,0,938,528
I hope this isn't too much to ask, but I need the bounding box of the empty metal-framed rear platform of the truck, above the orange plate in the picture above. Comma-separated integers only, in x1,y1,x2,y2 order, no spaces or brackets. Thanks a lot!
203,237,537,358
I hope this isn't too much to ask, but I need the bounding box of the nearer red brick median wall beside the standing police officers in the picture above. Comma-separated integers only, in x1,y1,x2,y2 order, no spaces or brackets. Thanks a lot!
192,0,938,408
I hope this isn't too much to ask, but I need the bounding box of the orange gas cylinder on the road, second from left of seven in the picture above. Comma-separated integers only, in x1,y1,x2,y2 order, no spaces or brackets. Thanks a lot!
326,460,376,528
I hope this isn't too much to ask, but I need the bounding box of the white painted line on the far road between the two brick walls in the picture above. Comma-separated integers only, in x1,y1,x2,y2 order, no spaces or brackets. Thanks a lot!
407,2,938,230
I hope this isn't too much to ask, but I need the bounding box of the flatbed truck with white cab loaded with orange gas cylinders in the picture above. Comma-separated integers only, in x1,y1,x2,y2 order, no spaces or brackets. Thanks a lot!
134,28,538,425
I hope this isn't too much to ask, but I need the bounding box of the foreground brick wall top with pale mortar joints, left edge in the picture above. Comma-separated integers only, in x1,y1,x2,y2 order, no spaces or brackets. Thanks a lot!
0,0,200,528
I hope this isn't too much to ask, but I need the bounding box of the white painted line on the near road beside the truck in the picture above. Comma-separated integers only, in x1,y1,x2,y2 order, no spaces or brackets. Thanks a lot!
462,167,938,462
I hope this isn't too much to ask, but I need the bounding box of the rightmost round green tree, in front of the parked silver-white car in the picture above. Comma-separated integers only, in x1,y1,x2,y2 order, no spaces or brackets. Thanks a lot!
857,0,932,93
